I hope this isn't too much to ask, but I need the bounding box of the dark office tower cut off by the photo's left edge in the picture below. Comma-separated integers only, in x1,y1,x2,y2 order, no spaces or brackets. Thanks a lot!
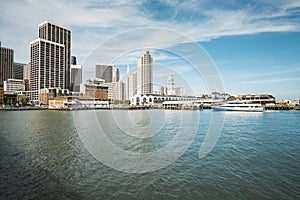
0,42,14,83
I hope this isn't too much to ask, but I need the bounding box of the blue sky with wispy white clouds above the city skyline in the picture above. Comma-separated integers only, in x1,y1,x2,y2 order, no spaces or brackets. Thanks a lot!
0,0,300,100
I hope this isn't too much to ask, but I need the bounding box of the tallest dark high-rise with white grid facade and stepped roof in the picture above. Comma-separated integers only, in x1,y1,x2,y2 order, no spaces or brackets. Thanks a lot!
30,21,71,101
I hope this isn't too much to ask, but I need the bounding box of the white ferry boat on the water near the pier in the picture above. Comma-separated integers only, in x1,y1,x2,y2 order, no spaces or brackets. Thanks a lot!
211,101,264,112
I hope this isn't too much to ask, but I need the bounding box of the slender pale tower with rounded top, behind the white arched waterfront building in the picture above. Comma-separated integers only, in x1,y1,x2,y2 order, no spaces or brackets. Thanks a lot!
137,50,153,94
